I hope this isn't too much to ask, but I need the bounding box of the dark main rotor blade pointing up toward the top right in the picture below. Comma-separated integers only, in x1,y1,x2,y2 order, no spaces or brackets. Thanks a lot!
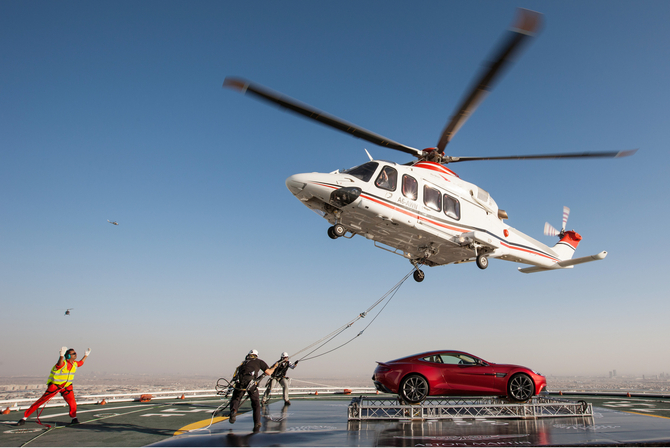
437,8,542,154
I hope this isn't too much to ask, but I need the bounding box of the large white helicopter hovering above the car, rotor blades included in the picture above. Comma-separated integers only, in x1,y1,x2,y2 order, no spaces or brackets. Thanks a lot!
223,8,637,282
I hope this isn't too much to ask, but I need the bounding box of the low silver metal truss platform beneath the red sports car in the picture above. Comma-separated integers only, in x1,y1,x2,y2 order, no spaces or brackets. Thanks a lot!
348,395,593,421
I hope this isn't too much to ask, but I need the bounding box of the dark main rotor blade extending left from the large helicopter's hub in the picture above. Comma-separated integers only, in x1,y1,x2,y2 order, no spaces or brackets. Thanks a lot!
223,76,423,157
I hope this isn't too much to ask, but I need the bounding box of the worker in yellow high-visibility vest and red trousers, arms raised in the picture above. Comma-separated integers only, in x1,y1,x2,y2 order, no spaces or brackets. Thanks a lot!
16,347,91,426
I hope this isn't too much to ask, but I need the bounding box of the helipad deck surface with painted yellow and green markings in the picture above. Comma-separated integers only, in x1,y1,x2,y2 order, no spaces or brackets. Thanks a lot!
0,395,670,447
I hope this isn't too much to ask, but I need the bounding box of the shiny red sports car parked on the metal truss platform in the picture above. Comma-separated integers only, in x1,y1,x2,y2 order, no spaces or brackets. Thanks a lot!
372,350,547,403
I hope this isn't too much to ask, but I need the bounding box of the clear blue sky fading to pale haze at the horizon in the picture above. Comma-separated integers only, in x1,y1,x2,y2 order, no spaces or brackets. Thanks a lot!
0,1,670,384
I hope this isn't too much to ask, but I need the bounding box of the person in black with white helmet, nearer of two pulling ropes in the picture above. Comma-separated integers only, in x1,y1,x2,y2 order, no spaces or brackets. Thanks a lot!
230,350,277,431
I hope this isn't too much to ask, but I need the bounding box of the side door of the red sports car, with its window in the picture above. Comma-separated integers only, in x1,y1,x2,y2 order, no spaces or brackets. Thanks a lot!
440,352,495,395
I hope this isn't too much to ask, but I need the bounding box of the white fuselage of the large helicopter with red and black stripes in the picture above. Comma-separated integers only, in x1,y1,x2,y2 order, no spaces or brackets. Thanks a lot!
286,160,605,272
